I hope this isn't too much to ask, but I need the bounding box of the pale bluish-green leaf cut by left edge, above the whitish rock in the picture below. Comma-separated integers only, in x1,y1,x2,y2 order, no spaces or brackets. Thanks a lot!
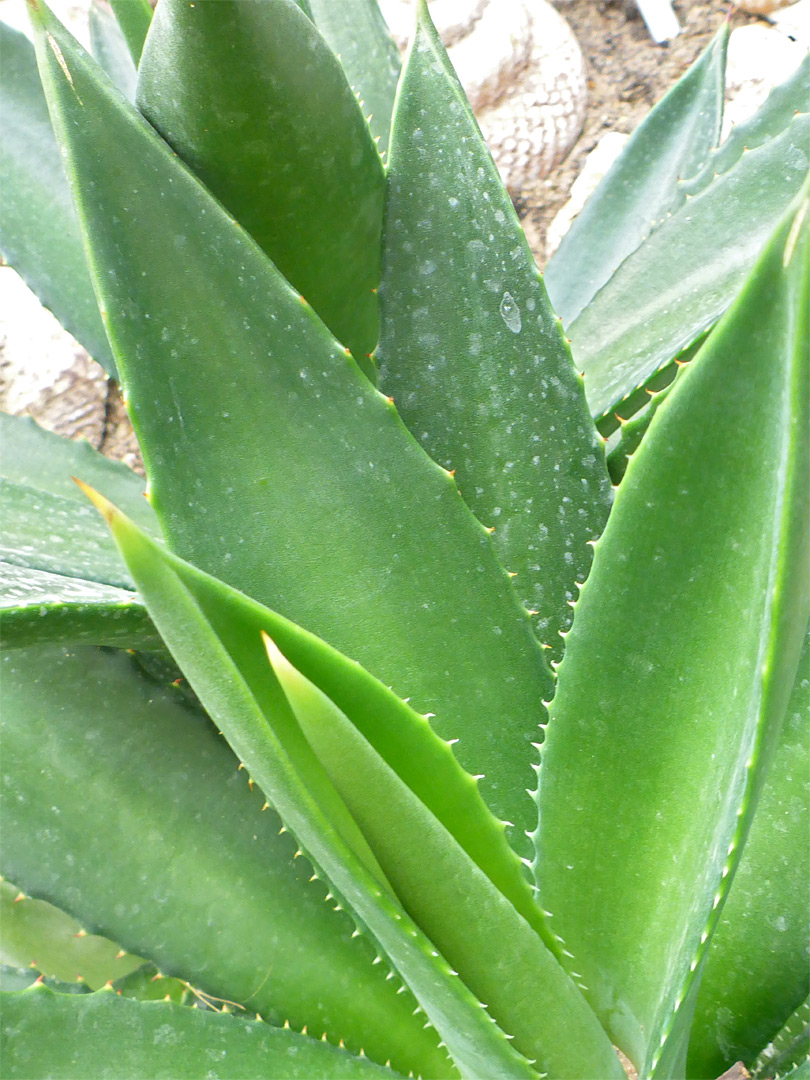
0,22,116,376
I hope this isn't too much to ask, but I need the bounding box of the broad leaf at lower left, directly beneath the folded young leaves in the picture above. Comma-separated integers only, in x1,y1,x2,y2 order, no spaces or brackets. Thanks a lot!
0,647,451,1078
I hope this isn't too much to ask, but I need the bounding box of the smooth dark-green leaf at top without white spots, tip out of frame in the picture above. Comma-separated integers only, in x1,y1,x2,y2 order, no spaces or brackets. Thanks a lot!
137,0,384,377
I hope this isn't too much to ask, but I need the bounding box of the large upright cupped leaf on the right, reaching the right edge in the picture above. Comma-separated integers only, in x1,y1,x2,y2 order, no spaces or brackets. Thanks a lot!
536,187,810,1076
